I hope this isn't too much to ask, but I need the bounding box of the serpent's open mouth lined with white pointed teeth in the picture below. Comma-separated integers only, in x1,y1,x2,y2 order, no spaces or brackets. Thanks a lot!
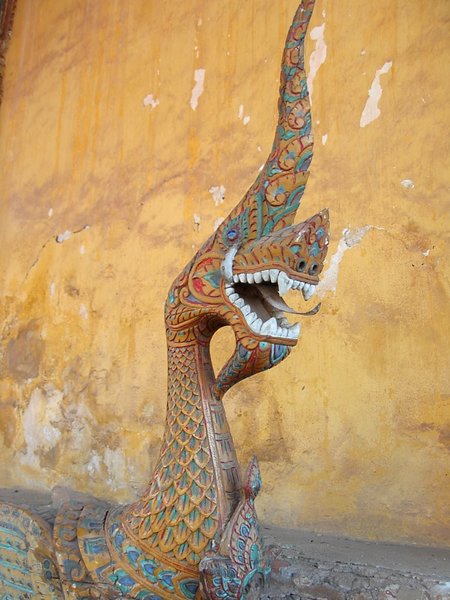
225,269,316,340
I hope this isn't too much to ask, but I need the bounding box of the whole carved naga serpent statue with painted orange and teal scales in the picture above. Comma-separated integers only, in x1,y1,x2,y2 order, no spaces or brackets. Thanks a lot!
0,0,329,600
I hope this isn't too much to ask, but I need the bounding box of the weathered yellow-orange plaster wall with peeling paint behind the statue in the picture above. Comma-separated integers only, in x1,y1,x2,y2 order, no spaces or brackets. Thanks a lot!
0,0,450,544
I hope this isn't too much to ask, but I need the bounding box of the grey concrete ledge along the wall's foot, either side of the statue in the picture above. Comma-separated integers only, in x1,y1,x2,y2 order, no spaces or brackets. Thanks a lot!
0,487,450,600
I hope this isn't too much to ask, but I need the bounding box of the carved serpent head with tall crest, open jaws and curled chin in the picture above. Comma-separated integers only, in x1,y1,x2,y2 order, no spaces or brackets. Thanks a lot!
166,0,329,393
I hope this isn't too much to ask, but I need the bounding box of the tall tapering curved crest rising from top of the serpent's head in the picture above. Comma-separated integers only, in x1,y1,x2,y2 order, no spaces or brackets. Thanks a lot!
217,0,314,243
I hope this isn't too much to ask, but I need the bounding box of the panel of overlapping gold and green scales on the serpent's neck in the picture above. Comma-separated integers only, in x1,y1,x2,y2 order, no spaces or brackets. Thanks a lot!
127,346,218,565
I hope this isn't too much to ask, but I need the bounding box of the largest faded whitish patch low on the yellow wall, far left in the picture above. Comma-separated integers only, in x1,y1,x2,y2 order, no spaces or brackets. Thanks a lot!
21,384,64,467
